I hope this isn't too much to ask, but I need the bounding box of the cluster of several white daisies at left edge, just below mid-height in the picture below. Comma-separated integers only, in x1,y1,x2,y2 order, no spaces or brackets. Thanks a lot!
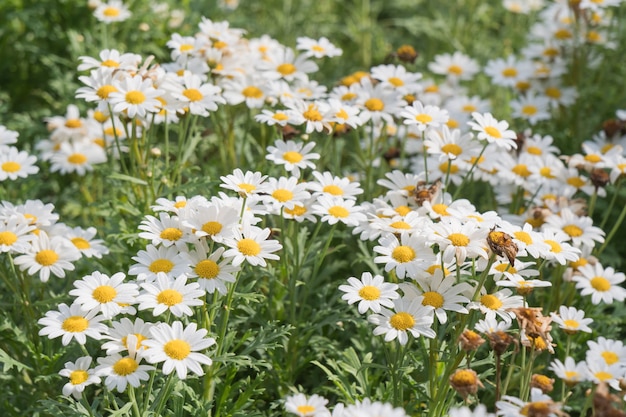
0,200,109,282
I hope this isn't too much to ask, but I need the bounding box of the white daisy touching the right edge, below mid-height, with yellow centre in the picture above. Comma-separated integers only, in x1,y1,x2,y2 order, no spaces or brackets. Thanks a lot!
572,262,626,305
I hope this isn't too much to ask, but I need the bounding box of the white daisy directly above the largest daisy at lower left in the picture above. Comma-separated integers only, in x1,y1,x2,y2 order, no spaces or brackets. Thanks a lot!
137,272,205,317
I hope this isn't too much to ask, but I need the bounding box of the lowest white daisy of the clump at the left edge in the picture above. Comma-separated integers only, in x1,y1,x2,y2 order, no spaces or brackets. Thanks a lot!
14,231,80,282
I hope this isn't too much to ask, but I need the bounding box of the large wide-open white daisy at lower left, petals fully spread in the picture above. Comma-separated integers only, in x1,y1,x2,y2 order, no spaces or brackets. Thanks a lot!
144,321,215,379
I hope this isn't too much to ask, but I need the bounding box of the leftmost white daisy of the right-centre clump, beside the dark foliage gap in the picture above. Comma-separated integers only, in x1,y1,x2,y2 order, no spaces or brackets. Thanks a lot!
339,272,400,314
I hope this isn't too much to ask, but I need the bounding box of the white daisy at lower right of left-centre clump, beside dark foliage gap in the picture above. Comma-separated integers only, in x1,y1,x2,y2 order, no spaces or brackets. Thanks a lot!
223,223,283,267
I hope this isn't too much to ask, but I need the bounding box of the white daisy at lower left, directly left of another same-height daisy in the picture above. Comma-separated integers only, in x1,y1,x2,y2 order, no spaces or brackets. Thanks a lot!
70,271,139,319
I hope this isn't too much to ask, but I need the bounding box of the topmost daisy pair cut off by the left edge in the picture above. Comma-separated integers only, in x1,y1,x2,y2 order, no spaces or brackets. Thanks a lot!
0,125,39,181
